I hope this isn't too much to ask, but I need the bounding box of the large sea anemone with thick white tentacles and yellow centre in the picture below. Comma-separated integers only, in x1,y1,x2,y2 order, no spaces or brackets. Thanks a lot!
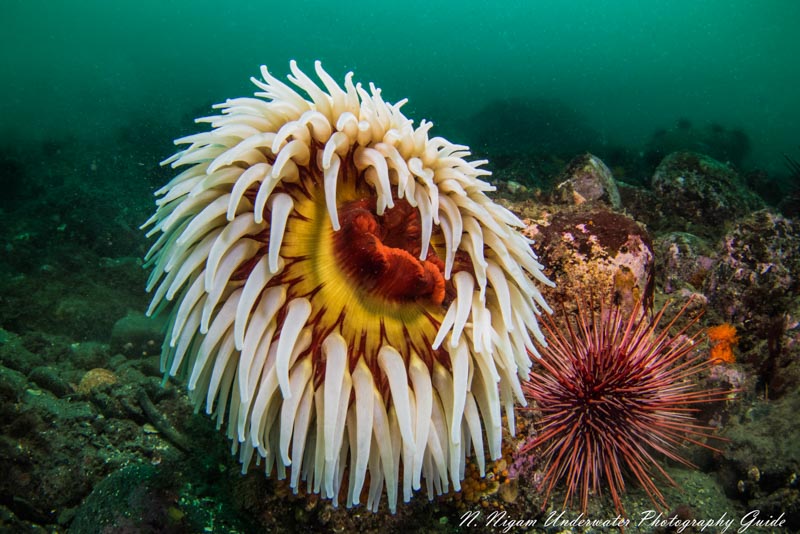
143,62,549,511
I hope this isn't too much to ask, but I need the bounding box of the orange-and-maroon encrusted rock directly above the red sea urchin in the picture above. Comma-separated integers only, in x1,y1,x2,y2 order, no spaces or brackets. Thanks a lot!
525,207,655,314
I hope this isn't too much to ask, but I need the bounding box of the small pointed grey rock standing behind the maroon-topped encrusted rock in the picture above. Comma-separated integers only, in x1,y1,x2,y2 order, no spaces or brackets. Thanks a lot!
557,154,620,208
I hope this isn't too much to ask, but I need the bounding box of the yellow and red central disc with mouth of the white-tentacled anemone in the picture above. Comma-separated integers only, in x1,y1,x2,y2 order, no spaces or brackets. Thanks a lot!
265,165,456,381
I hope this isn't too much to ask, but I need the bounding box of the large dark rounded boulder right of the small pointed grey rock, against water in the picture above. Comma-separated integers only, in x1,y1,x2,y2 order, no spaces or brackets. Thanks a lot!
652,152,764,238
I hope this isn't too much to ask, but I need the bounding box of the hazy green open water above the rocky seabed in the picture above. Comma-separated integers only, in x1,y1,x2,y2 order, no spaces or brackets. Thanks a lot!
0,0,800,169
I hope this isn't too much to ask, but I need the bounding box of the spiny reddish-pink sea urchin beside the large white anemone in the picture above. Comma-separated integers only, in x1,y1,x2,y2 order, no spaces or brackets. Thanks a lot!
522,301,729,513
